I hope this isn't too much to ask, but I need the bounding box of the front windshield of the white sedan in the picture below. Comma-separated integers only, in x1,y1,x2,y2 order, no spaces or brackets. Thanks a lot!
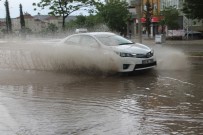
95,35,134,46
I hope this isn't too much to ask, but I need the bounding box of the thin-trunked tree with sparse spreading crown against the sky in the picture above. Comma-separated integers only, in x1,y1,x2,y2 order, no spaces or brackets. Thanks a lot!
33,0,94,29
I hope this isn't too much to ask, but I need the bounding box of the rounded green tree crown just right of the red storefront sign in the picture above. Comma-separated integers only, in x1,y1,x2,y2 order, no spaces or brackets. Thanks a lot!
160,6,179,29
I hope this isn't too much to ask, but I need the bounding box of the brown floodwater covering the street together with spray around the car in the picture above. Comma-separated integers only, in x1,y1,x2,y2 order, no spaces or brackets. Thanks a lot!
0,41,203,135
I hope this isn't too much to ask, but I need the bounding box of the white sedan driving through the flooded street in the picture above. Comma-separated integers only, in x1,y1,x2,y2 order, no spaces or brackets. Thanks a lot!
60,32,157,72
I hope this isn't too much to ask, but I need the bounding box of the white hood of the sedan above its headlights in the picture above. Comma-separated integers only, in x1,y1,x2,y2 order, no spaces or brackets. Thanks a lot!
112,43,151,54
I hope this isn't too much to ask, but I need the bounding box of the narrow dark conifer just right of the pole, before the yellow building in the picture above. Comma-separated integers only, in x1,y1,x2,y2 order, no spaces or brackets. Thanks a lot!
143,0,153,37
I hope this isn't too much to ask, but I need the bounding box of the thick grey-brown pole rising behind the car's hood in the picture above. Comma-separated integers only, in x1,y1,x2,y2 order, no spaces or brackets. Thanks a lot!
135,0,143,43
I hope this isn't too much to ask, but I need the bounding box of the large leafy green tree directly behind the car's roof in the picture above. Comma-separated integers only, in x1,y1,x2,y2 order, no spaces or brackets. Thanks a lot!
97,0,130,35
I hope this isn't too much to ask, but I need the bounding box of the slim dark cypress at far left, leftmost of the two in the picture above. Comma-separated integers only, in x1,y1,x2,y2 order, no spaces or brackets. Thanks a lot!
4,0,12,33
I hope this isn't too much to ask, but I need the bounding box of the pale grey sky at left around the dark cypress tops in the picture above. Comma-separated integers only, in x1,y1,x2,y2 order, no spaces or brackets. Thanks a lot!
0,0,48,18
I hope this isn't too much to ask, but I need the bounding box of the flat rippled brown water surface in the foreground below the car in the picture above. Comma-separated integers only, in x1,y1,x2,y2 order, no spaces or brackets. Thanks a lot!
0,67,203,135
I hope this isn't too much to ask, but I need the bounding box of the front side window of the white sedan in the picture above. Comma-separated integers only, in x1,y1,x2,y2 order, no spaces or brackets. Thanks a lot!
80,35,99,47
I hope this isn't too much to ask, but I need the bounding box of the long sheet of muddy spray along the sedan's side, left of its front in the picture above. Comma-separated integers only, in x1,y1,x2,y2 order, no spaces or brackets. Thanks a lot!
0,41,119,72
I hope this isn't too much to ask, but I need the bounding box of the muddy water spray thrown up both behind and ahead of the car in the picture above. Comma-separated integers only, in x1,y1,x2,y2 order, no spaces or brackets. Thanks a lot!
0,40,190,73
